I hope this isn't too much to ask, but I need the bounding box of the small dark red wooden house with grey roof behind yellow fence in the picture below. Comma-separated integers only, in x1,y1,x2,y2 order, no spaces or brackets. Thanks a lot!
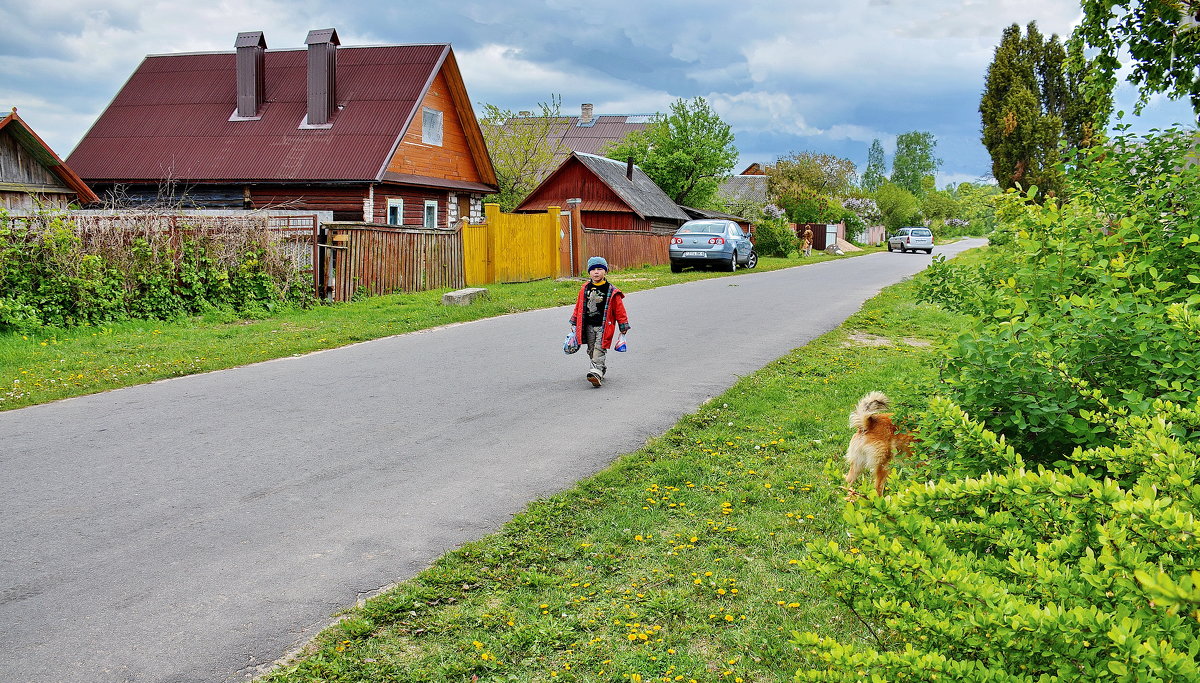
515,151,688,234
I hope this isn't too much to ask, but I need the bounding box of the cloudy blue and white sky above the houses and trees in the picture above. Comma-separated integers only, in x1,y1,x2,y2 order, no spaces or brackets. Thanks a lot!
0,0,1193,186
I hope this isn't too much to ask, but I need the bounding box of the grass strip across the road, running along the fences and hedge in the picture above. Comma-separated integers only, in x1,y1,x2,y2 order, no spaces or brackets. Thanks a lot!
0,248,880,411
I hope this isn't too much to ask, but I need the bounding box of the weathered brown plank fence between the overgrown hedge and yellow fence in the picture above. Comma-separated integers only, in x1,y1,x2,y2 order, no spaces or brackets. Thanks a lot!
325,223,466,301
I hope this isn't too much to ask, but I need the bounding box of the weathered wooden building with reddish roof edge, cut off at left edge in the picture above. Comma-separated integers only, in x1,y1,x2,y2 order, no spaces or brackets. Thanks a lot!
0,107,97,212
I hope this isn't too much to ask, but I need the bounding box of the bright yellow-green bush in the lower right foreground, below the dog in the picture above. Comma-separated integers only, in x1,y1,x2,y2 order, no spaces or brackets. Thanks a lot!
793,393,1200,682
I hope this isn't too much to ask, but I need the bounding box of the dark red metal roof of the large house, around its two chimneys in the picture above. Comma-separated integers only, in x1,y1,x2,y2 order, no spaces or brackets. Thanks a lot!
68,44,450,182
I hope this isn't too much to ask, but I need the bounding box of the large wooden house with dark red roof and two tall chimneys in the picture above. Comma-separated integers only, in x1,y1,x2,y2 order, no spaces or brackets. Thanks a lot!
68,29,497,223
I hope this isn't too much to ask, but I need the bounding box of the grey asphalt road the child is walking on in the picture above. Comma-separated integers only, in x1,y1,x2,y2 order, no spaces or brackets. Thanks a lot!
0,240,982,683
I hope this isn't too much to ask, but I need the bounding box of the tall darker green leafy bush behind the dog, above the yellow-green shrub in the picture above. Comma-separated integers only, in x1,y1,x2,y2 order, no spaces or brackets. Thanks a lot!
920,126,1200,463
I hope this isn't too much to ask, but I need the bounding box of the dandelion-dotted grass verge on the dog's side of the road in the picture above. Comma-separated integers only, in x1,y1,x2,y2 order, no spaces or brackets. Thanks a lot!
255,277,961,683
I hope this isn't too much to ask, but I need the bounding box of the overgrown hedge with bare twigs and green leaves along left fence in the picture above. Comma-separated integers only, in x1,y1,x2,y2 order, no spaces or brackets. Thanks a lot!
0,214,311,331
